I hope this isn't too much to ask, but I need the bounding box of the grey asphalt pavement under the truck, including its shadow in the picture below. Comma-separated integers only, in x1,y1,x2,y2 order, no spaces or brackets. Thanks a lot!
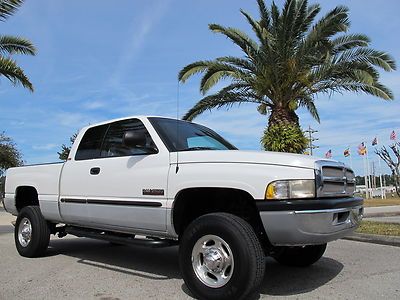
0,212,400,300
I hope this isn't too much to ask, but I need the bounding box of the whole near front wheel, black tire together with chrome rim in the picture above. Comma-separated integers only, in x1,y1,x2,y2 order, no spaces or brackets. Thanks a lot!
179,213,265,299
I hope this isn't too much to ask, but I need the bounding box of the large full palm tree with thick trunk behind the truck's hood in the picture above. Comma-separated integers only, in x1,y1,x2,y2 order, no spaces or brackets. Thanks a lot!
178,0,396,153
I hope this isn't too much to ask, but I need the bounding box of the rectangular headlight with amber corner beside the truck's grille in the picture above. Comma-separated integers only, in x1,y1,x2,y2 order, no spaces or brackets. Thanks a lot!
265,179,315,200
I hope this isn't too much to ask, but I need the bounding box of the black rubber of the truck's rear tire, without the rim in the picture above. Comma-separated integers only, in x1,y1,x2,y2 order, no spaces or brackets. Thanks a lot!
14,206,50,257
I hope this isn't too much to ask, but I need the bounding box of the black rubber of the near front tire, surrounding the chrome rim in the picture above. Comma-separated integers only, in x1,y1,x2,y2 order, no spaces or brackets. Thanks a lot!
179,213,265,300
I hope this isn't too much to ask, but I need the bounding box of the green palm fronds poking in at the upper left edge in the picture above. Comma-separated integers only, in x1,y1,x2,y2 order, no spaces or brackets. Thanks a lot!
0,0,36,92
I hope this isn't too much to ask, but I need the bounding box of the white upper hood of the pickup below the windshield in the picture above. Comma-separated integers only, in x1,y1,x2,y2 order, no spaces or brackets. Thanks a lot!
171,150,321,169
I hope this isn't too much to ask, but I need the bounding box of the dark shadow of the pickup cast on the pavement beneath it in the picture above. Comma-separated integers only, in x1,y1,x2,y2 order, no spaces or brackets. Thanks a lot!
47,238,343,299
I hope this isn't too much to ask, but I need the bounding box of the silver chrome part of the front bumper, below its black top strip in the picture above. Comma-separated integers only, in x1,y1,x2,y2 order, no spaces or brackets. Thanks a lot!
260,206,364,246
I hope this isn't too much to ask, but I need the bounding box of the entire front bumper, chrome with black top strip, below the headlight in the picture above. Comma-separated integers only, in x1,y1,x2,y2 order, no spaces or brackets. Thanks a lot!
256,198,363,246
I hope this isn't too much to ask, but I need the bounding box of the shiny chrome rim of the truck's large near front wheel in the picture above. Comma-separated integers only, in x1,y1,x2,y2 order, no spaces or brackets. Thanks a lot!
192,235,234,288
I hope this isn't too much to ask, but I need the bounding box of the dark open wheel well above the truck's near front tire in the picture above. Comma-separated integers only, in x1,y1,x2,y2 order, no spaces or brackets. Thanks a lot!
172,188,271,247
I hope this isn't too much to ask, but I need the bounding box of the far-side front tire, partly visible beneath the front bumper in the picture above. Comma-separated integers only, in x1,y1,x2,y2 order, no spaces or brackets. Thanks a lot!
273,244,326,267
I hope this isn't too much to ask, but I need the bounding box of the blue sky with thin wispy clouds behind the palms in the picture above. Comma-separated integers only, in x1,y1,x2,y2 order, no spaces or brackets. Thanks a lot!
0,0,400,175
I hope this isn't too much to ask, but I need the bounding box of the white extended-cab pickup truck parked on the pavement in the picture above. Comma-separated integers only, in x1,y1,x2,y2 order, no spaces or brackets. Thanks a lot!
4,117,363,299
